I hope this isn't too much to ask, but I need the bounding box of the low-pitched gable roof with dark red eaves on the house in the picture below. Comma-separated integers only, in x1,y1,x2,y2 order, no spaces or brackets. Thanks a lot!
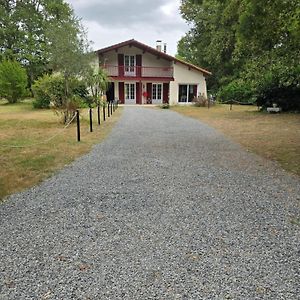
96,39,211,75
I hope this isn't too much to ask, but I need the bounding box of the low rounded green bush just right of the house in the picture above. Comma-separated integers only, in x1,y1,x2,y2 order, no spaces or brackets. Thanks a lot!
217,80,255,103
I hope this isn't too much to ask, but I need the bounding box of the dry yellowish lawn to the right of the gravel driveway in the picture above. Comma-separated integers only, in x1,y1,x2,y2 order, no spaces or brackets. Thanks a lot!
172,105,300,176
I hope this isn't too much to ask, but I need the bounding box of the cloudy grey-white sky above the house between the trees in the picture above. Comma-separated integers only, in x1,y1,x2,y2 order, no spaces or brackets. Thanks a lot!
66,0,188,55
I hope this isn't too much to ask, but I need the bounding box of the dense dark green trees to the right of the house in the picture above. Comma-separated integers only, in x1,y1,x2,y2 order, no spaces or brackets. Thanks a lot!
178,0,300,111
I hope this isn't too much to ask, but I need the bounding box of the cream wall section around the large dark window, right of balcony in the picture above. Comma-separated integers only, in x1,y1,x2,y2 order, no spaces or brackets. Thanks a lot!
169,62,207,104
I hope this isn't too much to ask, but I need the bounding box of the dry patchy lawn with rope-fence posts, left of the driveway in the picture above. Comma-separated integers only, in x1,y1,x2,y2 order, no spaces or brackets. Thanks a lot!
0,100,122,199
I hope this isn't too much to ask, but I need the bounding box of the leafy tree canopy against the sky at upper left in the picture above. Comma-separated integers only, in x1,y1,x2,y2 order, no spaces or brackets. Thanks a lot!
0,0,89,86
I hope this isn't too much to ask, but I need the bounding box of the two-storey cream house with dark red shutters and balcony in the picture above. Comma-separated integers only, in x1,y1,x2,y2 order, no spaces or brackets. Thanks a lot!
96,39,211,104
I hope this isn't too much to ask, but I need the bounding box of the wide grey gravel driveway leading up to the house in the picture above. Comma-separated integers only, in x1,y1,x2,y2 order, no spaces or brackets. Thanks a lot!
0,107,300,300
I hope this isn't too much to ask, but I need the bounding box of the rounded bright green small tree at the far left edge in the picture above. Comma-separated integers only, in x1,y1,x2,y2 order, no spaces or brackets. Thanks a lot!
0,60,27,103
